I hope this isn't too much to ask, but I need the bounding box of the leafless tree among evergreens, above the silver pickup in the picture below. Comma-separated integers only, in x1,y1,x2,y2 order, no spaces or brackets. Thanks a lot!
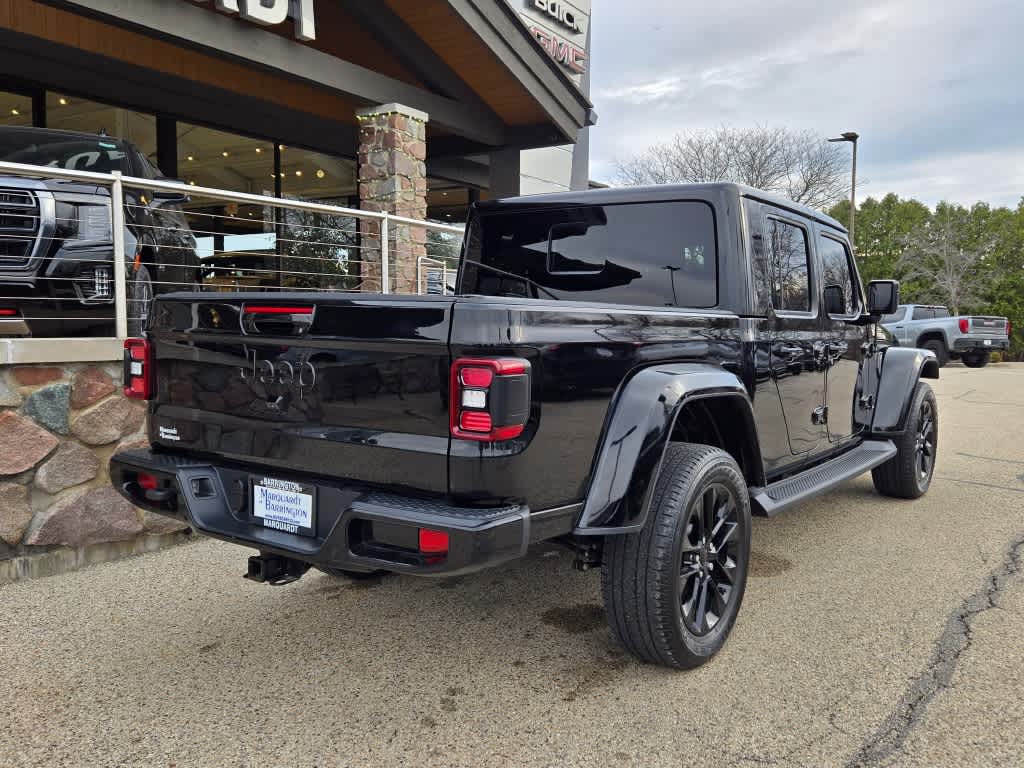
898,203,995,314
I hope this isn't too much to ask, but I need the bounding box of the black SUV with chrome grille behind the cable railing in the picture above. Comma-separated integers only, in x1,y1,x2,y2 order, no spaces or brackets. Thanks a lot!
0,127,199,336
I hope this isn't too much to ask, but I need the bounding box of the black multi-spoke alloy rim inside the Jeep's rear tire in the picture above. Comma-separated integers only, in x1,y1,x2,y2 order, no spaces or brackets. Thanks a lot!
679,483,739,636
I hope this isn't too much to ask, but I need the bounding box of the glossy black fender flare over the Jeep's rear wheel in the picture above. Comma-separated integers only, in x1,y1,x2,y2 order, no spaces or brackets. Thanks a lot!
573,362,761,536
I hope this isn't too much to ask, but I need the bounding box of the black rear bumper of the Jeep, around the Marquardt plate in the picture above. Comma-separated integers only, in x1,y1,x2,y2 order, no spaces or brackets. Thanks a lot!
111,451,577,575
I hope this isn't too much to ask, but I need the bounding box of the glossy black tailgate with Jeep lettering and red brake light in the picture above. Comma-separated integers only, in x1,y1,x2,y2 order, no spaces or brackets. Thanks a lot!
150,293,455,493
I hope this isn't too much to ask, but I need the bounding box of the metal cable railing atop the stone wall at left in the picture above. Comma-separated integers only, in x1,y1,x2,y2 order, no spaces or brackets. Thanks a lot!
0,162,463,362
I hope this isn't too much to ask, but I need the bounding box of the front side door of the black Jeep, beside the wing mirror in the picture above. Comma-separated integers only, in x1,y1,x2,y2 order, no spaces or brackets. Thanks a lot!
817,230,866,442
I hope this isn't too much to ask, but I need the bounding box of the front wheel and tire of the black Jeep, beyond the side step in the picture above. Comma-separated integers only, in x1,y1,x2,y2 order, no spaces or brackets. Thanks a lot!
871,381,939,499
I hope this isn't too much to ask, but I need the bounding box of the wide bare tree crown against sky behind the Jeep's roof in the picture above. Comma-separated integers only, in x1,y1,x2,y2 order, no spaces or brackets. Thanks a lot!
616,126,849,209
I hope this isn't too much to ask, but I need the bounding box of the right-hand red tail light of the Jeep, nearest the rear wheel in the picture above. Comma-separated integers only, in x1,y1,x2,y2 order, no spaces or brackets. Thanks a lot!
450,357,529,442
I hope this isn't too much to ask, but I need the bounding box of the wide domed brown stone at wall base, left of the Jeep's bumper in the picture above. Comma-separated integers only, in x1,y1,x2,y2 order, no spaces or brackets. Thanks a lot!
25,487,142,547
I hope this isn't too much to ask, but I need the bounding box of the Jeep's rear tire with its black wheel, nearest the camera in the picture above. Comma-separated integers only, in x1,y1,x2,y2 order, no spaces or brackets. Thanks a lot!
601,443,751,669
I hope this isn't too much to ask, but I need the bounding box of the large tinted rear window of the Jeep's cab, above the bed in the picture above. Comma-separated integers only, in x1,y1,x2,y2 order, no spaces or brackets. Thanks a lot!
462,201,718,308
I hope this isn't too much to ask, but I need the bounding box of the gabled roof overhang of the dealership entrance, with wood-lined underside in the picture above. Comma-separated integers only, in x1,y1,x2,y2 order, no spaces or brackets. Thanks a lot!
39,0,593,155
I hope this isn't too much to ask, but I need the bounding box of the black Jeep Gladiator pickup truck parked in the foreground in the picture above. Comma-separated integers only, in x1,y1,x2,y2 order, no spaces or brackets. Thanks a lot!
111,184,939,667
